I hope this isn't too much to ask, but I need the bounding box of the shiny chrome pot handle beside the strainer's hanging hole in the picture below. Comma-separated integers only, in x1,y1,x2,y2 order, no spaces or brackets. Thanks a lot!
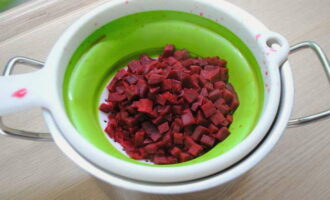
288,41,330,126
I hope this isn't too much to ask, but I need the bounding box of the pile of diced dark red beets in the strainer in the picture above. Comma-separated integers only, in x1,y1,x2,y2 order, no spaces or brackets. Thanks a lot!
100,45,239,164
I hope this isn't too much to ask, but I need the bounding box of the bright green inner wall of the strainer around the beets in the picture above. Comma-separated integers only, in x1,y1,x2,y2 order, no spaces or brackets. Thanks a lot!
63,11,264,167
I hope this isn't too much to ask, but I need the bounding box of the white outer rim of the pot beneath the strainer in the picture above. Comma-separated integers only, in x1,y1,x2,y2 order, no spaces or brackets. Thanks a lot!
44,62,294,194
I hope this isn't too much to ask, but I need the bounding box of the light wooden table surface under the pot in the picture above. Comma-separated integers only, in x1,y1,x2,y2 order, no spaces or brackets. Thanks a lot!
0,0,330,200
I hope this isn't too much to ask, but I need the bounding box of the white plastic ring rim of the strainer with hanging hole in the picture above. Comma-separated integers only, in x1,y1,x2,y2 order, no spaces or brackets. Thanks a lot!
36,0,288,182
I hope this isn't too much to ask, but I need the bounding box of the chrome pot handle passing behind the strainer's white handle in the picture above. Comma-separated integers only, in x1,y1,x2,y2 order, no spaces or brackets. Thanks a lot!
0,57,53,141
